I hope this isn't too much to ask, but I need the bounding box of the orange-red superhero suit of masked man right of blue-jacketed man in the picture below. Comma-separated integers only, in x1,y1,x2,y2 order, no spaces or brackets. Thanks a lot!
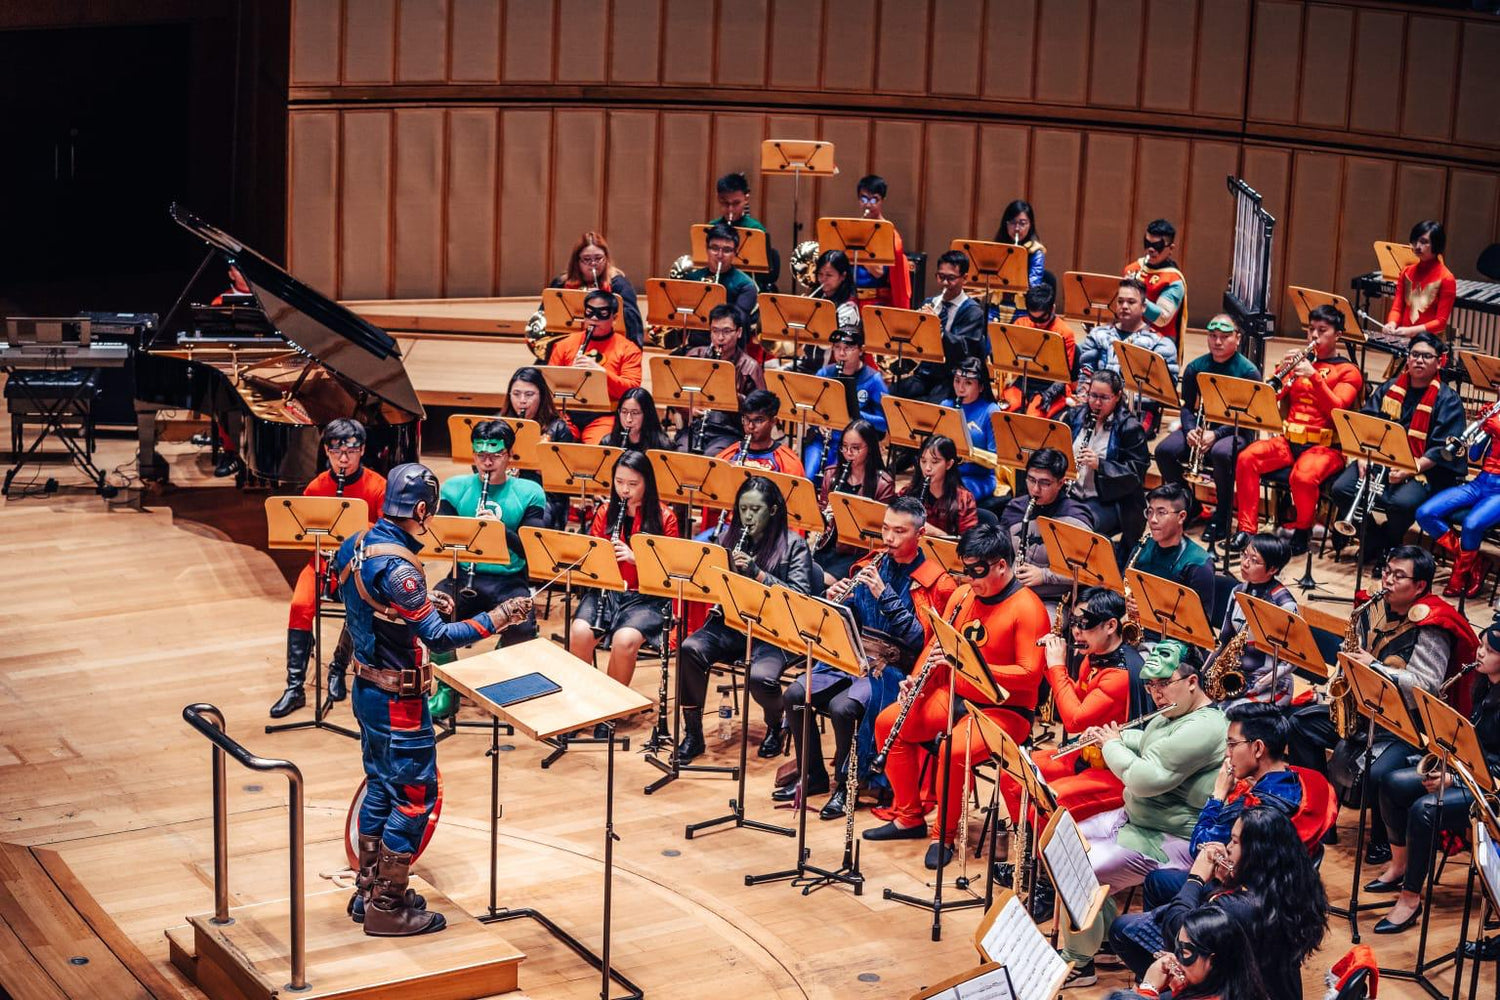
875,580,1050,844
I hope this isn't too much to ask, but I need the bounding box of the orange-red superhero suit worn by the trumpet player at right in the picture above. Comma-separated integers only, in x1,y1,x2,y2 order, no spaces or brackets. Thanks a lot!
1235,354,1365,532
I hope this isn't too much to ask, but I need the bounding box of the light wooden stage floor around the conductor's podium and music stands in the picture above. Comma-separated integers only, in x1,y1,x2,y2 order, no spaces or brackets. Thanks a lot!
0,407,1494,1000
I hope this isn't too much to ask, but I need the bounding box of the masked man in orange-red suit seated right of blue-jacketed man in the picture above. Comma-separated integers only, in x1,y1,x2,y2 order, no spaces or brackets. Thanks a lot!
863,525,1049,870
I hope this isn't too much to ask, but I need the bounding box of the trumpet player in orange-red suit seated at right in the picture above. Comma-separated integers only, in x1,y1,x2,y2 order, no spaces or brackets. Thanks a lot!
1230,306,1365,556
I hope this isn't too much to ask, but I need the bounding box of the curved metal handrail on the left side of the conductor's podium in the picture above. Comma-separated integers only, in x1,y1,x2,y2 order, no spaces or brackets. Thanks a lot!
183,702,308,991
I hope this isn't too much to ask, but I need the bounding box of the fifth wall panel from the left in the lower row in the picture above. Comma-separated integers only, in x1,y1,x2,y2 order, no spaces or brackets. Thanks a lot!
497,112,558,295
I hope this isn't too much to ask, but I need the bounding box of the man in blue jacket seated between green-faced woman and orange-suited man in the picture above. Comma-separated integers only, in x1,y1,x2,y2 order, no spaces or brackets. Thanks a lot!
771,496,956,820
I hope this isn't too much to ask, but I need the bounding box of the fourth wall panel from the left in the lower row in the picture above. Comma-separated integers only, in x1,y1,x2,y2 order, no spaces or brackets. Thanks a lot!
441,108,500,297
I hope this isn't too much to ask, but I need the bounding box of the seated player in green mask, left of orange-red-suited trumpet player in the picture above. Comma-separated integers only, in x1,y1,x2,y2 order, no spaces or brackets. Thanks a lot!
1157,312,1263,541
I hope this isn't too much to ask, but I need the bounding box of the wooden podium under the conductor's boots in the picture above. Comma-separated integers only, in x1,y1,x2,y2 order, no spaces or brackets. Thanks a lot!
167,877,525,1000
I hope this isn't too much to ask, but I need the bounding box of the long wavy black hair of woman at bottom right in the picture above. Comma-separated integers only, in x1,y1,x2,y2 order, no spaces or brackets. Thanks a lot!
1233,805,1328,966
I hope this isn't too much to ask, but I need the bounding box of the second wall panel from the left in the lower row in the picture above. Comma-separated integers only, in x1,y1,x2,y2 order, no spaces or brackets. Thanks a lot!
339,111,392,298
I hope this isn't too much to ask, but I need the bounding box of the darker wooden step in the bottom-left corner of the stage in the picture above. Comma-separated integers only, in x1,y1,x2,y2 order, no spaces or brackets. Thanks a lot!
0,844,182,1000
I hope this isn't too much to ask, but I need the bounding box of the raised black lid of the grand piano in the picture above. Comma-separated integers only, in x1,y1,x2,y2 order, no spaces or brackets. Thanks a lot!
171,204,426,418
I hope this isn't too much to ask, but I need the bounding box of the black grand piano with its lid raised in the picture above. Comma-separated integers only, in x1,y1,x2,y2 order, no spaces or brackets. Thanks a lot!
135,205,425,487
